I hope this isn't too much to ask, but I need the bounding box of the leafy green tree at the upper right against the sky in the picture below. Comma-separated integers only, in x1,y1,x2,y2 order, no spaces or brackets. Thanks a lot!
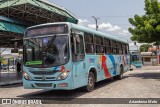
128,0,160,43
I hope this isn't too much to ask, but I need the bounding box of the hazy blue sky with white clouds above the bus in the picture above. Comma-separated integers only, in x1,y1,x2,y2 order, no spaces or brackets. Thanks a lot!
49,0,145,50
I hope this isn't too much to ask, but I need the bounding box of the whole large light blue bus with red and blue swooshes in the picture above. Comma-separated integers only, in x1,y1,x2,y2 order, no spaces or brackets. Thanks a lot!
23,22,130,92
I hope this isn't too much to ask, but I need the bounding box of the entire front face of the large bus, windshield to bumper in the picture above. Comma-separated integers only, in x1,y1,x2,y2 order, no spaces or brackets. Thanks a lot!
23,23,73,90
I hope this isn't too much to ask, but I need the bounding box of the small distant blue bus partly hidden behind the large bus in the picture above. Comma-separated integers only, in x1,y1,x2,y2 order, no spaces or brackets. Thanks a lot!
130,51,143,68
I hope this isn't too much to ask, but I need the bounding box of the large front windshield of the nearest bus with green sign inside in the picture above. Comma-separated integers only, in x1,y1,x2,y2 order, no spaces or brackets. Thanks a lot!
24,34,69,67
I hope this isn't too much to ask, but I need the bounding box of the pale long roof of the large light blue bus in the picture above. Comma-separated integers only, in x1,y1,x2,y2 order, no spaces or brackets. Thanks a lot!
27,22,128,44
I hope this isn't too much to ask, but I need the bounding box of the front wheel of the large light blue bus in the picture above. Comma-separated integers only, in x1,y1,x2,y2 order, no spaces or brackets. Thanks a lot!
84,72,95,92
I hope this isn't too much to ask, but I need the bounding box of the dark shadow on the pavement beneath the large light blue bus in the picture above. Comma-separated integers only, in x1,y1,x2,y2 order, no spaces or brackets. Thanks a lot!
17,78,116,99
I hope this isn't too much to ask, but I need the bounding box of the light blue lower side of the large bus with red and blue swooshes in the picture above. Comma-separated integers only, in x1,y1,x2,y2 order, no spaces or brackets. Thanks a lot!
73,54,129,88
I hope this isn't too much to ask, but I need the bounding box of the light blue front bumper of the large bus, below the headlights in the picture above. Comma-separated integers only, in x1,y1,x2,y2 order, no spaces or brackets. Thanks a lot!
23,78,73,90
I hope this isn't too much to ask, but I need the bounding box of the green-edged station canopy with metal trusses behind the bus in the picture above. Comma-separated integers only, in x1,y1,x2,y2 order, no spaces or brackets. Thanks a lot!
0,0,78,48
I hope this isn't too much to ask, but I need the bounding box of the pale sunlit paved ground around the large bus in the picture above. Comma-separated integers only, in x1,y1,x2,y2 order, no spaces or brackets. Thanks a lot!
0,66,160,107
